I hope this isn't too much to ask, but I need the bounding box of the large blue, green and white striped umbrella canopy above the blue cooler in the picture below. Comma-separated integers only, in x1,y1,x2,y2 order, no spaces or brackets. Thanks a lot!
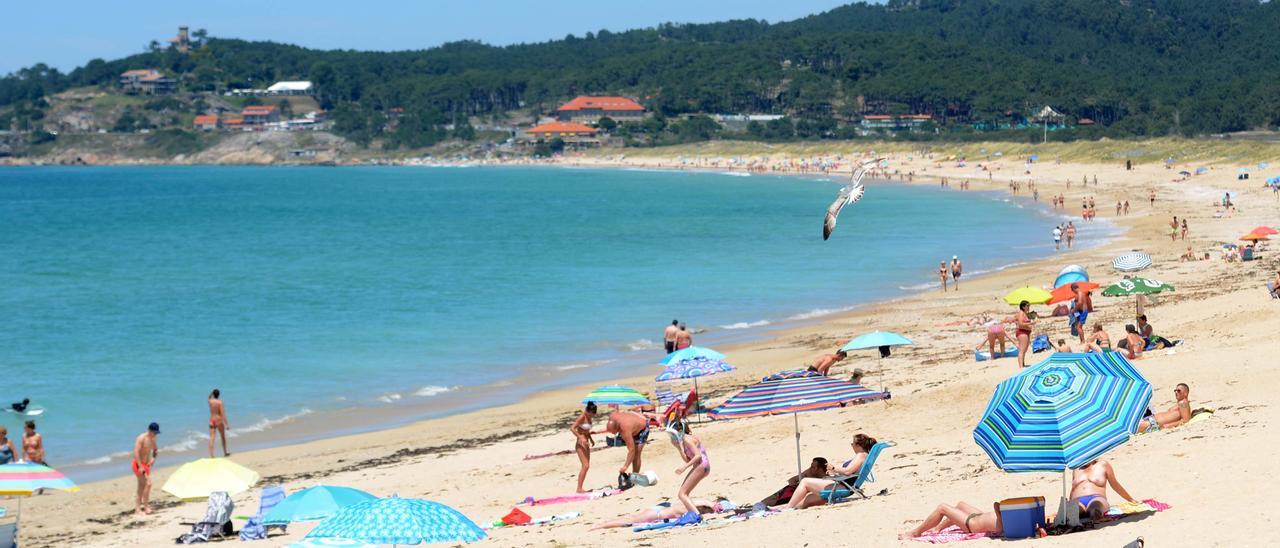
973,352,1151,472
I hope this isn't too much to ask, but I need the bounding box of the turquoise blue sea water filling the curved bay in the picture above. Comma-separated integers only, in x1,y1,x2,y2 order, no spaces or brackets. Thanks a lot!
0,166,1088,475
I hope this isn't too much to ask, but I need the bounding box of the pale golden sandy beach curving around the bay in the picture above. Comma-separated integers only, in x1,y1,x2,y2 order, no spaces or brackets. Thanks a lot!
6,146,1280,547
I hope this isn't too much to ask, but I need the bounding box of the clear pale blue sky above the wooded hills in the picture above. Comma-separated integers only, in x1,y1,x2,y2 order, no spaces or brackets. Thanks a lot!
0,0,852,74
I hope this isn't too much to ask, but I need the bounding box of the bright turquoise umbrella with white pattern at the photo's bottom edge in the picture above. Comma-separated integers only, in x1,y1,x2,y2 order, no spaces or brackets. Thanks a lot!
307,497,486,544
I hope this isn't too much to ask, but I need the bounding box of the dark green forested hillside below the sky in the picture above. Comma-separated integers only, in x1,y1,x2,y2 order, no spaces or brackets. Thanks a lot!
0,0,1280,143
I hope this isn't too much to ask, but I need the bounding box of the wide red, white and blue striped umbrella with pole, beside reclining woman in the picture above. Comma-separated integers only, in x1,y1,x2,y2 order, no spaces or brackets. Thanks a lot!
707,370,886,471
